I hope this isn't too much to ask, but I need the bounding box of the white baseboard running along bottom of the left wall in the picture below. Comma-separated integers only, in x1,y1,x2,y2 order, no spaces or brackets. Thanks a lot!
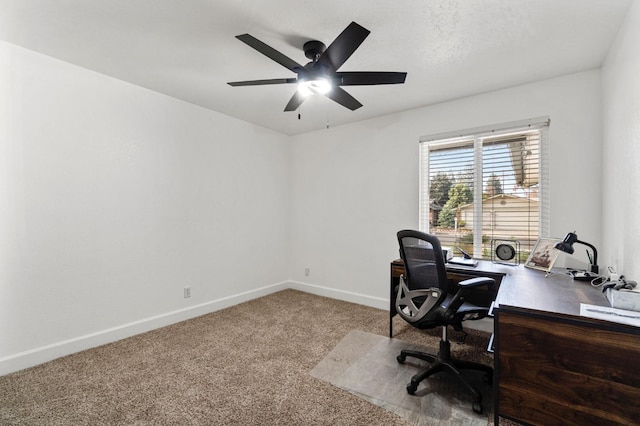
0,281,290,376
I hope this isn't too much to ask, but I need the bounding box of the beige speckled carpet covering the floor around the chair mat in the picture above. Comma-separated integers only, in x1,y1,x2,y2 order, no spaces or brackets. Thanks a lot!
0,290,491,425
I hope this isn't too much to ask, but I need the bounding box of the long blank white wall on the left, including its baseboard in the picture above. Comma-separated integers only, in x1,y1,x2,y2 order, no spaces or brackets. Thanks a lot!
0,43,290,374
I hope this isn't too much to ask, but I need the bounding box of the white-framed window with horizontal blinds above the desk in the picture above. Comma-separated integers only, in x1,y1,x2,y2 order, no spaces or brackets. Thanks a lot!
420,117,549,260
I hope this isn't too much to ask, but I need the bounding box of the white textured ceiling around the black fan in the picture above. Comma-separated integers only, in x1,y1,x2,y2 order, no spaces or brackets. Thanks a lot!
0,0,633,135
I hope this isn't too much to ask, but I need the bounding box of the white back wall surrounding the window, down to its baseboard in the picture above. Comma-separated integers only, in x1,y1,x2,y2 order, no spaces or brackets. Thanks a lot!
290,70,602,308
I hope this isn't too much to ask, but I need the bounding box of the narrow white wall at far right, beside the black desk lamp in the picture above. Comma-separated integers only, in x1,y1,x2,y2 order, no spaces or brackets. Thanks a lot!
600,1,640,281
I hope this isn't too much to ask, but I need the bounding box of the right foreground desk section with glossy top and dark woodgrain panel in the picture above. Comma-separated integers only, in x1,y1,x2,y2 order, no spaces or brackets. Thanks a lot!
494,267,640,425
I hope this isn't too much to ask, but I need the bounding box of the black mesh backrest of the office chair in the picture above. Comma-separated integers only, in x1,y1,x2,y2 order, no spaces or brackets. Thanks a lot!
398,230,447,290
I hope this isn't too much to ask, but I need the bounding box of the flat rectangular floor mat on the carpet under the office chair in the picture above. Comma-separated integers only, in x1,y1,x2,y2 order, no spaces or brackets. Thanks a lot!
311,330,493,426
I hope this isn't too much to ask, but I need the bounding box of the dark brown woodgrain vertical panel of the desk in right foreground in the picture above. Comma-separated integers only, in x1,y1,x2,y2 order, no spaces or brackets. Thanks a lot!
496,307,640,425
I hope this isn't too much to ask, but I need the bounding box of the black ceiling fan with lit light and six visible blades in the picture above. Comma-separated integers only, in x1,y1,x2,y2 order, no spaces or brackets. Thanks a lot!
228,22,407,111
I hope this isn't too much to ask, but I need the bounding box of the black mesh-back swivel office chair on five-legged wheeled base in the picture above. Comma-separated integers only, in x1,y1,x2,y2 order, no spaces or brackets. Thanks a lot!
395,230,495,413
